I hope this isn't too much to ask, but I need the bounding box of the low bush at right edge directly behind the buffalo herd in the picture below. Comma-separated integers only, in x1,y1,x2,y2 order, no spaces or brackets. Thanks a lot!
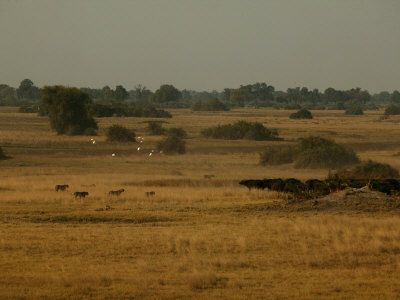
337,160,399,179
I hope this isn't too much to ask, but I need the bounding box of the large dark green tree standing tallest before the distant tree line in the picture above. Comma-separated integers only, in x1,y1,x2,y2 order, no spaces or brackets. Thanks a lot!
42,85,97,135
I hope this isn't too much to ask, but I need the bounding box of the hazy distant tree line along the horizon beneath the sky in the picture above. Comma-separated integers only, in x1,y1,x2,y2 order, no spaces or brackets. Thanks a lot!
0,79,400,113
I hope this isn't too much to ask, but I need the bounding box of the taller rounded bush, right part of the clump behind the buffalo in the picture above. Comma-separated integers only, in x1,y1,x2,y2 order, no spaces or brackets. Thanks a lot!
295,136,360,169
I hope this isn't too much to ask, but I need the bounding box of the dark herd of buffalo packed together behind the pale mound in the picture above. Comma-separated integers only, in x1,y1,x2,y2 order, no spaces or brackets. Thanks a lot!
239,176,400,199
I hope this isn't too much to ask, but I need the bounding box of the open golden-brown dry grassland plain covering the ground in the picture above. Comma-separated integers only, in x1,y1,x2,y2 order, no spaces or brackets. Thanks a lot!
0,108,400,299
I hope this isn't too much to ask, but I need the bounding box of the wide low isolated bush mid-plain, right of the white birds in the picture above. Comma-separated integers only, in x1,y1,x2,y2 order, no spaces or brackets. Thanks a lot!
201,121,280,141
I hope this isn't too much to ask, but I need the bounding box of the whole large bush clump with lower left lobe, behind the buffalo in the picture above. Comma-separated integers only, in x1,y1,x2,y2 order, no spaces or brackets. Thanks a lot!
260,136,360,169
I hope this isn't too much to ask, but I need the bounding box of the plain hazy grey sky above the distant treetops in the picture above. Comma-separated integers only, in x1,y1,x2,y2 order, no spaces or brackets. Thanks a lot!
0,0,400,92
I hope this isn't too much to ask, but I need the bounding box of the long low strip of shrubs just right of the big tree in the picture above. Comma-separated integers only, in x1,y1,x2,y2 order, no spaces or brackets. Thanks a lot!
89,103,172,118
